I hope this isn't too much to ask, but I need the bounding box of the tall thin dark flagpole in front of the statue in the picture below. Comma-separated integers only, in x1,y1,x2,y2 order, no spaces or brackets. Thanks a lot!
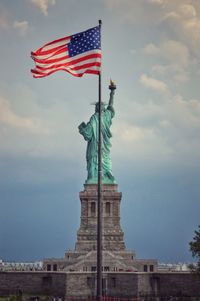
96,20,102,301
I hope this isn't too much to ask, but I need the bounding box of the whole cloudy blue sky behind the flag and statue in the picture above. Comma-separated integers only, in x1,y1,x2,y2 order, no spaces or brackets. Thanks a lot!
0,0,200,262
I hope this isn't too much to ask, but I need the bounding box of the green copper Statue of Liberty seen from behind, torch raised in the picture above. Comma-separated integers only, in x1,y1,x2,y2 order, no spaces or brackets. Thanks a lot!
78,81,116,184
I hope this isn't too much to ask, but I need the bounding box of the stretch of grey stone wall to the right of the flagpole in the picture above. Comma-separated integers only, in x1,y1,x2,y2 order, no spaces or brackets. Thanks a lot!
104,272,200,298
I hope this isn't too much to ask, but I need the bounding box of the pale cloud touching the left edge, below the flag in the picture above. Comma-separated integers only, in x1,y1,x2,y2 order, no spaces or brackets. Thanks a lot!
0,97,49,135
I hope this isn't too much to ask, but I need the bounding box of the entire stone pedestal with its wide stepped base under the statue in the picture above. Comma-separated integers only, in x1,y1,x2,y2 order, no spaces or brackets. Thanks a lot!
44,184,157,274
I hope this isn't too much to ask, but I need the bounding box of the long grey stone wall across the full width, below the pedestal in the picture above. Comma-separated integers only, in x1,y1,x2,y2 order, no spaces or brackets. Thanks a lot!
0,272,200,299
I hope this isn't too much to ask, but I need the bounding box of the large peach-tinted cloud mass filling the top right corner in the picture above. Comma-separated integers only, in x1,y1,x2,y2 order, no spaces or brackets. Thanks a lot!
104,0,200,57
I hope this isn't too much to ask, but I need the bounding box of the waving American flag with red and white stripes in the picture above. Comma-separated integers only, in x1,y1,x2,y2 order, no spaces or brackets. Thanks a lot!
31,26,101,78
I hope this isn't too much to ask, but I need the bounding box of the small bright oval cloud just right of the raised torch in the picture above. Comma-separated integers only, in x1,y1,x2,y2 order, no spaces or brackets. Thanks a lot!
140,74,169,93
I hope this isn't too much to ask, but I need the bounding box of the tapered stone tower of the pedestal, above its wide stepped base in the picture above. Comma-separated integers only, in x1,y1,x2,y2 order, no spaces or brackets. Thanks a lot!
75,184,125,252
